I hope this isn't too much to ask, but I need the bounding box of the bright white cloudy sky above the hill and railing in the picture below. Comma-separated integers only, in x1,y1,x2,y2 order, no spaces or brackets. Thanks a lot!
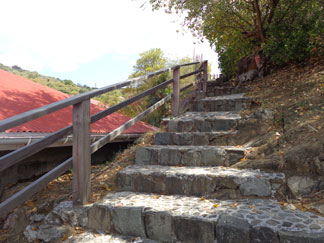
0,0,219,87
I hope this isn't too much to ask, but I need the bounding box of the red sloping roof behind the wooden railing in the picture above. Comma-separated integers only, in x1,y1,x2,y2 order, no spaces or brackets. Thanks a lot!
0,69,155,133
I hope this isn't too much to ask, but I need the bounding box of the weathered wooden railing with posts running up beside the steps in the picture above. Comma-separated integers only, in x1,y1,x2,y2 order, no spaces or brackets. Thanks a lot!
0,61,208,218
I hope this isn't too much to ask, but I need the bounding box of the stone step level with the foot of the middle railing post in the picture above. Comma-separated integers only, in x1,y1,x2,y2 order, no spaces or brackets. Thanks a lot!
168,112,241,132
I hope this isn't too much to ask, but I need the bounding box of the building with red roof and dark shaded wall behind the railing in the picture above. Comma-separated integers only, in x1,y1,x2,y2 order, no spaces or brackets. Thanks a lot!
0,69,156,196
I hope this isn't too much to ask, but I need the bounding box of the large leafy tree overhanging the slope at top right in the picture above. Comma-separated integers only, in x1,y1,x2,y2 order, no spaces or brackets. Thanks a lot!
149,0,324,75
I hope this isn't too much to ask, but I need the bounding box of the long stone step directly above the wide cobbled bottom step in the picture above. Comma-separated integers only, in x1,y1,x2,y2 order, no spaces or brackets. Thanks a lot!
117,165,286,199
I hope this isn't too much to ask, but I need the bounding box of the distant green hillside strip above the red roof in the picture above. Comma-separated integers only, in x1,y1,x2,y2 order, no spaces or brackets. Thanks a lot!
0,64,91,95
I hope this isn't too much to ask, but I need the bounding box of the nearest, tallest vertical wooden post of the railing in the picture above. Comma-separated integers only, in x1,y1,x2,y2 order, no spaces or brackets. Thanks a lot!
72,99,91,205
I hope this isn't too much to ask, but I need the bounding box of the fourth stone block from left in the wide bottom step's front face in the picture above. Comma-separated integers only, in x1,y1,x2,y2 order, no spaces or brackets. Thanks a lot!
173,217,215,243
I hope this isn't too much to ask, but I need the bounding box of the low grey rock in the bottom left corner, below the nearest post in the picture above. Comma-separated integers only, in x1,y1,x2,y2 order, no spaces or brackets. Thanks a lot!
24,224,72,242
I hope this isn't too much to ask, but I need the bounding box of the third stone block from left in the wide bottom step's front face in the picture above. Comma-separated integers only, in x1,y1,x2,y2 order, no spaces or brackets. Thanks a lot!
144,211,173,242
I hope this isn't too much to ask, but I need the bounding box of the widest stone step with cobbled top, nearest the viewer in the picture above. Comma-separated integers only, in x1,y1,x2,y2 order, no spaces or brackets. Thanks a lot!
84,192,324,243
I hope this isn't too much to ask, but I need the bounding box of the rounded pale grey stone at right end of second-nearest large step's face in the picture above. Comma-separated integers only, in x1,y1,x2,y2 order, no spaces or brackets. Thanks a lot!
240,177,271,197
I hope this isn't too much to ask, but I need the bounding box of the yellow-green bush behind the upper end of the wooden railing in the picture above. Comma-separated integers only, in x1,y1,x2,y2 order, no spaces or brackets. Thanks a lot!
99,48,197,126
